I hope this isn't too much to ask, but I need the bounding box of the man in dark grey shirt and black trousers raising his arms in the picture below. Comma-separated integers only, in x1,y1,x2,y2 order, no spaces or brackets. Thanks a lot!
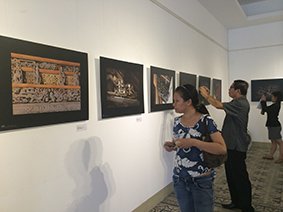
199,80,254,212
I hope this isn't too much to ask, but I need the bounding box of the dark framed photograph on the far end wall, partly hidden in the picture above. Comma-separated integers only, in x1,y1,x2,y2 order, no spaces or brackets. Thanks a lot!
251,79,283,102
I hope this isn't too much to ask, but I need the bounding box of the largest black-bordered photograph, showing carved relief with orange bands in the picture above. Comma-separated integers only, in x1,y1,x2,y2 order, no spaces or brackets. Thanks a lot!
0,36,88,130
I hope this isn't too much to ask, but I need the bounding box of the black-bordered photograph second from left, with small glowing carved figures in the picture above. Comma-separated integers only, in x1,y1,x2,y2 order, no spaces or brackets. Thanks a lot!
100,57,144,118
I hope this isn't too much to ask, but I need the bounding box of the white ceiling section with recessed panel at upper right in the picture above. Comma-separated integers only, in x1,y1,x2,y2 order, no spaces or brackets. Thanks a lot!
198,0,283,29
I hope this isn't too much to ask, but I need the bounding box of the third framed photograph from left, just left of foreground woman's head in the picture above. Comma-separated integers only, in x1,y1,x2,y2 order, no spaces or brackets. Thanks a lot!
150,66,175,112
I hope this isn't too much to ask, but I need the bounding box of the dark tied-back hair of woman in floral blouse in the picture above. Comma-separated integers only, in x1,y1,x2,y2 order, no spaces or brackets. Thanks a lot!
175,84,209,114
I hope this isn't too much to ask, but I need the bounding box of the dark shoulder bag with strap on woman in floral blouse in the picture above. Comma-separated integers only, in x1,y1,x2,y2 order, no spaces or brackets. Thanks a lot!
203,116,227,168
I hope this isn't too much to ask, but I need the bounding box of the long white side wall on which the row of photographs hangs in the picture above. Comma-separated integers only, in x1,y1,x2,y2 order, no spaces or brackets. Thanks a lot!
0,0,229,212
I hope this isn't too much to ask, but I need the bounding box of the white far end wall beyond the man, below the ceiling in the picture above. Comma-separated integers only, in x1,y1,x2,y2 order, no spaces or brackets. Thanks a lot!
229,22,283,142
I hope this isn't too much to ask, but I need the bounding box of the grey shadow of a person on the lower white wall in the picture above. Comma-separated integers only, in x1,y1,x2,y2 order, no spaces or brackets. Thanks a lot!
65,137,115,212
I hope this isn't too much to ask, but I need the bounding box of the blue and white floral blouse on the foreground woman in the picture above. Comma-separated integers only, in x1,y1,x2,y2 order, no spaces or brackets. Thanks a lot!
173,114,218,177
